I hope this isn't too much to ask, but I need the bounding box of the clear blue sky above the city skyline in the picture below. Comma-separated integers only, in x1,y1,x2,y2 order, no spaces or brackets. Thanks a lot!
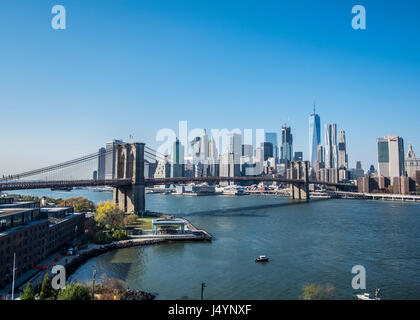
0,0,420,174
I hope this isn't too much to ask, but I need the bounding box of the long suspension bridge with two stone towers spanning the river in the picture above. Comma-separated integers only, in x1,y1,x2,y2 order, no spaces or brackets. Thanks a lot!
0,143,355,213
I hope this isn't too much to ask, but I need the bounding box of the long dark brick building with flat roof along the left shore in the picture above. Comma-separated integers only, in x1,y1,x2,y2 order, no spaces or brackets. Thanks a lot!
0,197,85,288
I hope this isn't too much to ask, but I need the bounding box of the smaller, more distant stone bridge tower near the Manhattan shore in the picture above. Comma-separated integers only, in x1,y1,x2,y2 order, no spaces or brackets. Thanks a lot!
290,161,309,201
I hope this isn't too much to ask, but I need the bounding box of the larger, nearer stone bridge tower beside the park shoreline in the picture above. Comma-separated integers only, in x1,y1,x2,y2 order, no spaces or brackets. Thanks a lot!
114,143,146,214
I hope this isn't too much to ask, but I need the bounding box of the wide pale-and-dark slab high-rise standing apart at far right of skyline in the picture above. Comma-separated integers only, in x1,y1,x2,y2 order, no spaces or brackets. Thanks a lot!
376,135,405,178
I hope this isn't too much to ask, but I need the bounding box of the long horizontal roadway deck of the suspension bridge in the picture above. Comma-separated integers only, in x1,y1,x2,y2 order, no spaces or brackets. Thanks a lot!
0,176,357,191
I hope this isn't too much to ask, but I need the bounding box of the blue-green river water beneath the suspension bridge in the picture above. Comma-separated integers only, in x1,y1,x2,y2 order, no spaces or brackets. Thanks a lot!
14,190,420,299
